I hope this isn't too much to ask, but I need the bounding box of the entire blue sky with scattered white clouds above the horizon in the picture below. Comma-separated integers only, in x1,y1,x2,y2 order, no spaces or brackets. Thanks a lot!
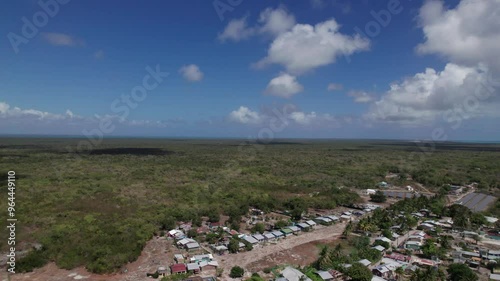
0,0,500,140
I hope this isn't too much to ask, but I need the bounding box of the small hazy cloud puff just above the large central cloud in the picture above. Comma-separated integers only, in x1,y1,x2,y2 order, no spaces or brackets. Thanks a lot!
259,7,295,36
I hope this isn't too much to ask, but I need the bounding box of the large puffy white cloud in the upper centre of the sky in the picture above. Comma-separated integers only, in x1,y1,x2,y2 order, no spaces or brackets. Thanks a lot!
256,19,370,74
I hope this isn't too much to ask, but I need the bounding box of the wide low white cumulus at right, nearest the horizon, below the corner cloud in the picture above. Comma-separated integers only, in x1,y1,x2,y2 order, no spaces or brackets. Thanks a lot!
366,63,498,123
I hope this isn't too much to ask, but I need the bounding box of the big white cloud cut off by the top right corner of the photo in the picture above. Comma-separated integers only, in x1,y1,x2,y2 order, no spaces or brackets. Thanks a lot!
417,0,500,72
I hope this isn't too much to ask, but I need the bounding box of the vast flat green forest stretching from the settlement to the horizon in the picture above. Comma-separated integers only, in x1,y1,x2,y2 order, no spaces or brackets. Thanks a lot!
0,138,500,273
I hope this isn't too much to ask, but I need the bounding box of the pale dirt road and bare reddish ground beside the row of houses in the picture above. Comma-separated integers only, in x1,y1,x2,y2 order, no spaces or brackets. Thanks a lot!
215,223,345,280
